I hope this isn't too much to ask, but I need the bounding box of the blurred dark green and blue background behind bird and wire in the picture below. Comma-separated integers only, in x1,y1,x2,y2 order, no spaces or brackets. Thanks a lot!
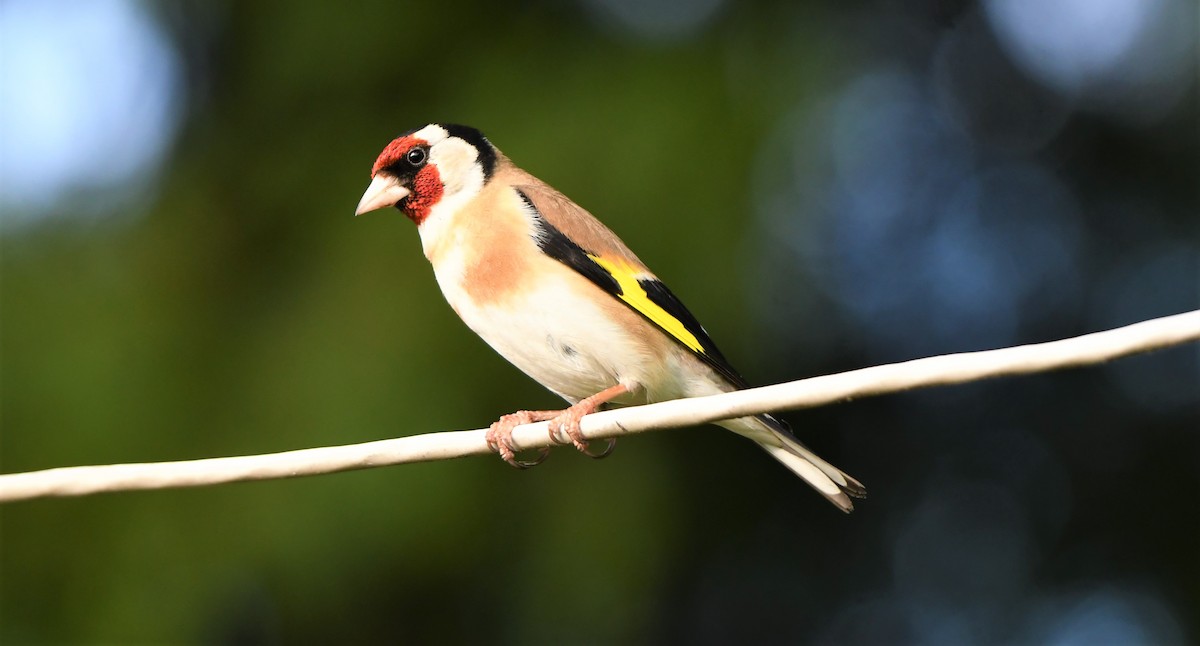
0,0,1200,644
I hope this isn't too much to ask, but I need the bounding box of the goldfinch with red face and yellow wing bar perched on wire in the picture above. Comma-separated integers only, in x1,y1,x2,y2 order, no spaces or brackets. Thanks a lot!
355,124,866,513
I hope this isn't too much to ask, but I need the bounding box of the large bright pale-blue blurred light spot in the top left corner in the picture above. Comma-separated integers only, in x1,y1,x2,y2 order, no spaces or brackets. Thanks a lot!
0,0,180,221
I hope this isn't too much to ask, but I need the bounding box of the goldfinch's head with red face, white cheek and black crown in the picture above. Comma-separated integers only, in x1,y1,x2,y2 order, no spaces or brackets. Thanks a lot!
354,124,497,225
